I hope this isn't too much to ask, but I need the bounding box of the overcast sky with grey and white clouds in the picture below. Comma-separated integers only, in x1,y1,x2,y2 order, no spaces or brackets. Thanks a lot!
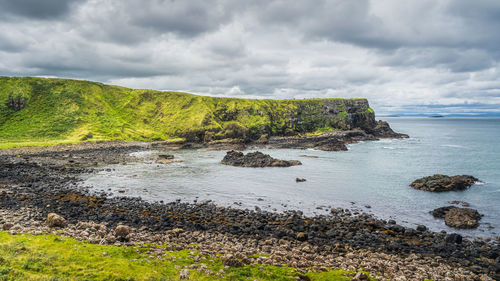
0,0,500,114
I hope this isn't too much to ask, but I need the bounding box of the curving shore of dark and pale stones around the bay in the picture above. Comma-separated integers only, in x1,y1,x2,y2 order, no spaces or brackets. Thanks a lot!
0,142,500,280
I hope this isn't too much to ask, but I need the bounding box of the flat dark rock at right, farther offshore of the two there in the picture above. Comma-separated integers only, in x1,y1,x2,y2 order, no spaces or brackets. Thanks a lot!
410,174,479,192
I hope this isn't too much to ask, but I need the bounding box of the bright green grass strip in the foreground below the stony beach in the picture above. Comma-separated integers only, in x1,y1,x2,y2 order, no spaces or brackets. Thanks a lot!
0,231,368,280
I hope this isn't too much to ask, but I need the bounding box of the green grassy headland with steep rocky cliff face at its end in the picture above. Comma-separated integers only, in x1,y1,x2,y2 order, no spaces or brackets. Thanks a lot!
0,77,375,147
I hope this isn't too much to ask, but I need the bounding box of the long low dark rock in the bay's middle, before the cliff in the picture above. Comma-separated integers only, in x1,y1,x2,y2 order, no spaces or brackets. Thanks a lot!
221,150,302,167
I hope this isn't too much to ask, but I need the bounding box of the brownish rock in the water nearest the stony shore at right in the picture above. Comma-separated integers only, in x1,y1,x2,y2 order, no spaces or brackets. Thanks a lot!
430,206,483,229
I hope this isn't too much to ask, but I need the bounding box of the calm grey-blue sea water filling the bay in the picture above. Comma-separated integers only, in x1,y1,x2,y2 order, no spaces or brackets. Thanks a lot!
84,118,500,237
